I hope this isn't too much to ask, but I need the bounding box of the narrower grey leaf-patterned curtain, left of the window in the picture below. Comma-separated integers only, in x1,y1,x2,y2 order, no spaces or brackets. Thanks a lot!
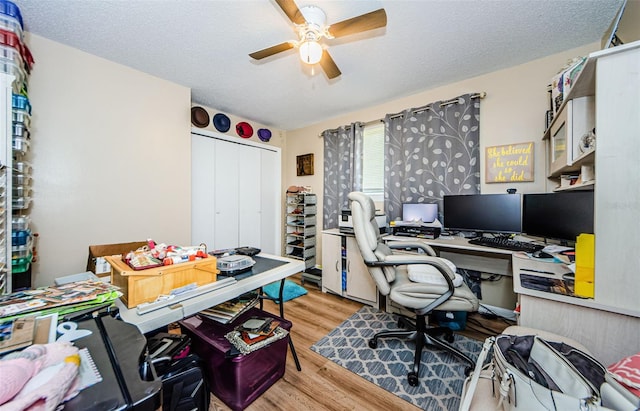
321,123,363,230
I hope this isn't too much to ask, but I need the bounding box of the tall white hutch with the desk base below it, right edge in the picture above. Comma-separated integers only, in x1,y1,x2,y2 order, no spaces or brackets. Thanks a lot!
514,41,640,364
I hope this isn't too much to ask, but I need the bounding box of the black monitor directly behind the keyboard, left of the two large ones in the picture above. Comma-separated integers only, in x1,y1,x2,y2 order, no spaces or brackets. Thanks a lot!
443,194,522,235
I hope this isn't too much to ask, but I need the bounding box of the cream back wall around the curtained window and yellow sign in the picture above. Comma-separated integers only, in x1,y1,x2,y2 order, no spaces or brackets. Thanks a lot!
283,43,600,268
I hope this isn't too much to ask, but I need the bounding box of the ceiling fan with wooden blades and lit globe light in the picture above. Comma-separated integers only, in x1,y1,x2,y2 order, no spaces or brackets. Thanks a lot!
249,0,387,79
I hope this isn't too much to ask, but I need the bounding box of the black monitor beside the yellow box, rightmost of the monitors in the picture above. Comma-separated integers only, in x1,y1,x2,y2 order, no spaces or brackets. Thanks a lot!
522,191,593,242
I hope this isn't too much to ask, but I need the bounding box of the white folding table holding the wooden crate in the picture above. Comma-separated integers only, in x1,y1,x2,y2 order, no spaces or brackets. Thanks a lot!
116,253,305,333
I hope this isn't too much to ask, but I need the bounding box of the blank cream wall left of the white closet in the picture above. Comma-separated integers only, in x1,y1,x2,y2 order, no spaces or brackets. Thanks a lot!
26,34,191,286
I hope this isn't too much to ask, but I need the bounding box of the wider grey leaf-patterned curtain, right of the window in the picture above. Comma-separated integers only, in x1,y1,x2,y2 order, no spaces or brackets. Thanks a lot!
384,94,480,221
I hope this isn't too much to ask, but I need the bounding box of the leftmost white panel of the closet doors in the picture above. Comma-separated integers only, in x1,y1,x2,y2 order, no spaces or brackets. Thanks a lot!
191,135,216,250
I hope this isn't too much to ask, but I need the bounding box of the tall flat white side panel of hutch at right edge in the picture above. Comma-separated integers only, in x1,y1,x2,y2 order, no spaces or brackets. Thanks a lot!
594,41,640,317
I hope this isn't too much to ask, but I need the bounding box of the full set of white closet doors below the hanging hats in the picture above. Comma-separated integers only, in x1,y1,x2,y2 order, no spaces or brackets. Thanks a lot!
191,130,281,254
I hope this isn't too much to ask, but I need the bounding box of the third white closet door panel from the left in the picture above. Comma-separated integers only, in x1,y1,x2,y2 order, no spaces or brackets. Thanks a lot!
237,145,264,248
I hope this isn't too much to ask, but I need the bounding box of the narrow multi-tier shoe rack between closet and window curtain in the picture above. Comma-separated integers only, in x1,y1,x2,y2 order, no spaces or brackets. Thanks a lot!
285,193,317,270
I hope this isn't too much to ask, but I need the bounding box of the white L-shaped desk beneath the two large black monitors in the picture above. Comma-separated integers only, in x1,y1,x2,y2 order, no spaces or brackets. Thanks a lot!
385,236,640,365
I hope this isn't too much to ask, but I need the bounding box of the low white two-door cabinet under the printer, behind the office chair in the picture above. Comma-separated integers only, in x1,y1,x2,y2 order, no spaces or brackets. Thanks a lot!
322,229,378,308
